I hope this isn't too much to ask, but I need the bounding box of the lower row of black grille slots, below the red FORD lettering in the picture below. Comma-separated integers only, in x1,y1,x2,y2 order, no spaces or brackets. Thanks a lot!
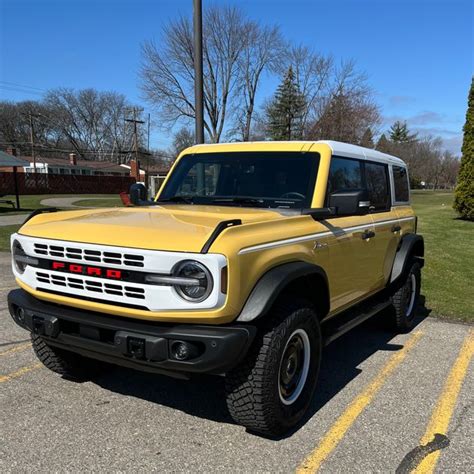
36,271,145,300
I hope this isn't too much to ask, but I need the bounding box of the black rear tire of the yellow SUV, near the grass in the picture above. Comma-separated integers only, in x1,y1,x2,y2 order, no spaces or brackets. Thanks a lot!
392,260,421,333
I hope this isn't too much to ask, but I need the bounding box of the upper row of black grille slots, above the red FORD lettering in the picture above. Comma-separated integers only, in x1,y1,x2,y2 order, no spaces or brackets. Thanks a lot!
33,243,144,267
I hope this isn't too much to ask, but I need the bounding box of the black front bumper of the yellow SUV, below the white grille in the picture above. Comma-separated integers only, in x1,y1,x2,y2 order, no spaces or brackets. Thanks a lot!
8,289,256,377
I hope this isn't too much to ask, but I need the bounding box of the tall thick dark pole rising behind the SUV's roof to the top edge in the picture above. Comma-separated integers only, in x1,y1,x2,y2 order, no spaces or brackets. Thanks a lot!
194,0,204,143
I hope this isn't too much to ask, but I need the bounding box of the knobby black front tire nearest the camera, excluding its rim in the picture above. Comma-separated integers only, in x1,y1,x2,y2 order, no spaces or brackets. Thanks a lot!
225,298,322,436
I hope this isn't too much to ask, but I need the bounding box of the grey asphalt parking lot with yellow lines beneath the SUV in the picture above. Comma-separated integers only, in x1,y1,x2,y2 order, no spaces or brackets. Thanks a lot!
0,253,474,473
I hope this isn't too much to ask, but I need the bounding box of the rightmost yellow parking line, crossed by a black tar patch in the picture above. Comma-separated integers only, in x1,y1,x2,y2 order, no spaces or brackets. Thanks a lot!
413,329,474,473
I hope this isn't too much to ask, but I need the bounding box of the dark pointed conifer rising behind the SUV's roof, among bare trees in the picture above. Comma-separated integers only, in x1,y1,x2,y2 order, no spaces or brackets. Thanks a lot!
266,66,306,140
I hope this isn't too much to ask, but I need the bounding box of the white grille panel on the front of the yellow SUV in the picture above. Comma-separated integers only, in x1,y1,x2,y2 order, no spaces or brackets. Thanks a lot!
11,234,227,312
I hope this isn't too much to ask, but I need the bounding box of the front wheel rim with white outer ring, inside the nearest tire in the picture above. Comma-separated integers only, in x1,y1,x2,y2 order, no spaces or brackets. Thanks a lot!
278,329,311,405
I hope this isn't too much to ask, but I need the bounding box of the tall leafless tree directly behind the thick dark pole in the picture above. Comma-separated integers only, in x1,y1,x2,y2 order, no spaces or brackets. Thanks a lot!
140,6,248,142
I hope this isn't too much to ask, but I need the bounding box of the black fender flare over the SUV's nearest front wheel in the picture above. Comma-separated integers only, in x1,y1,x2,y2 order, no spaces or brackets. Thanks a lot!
237,261,330,322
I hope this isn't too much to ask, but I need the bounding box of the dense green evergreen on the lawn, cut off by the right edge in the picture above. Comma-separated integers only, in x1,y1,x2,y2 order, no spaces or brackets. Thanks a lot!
454,78,474,221
